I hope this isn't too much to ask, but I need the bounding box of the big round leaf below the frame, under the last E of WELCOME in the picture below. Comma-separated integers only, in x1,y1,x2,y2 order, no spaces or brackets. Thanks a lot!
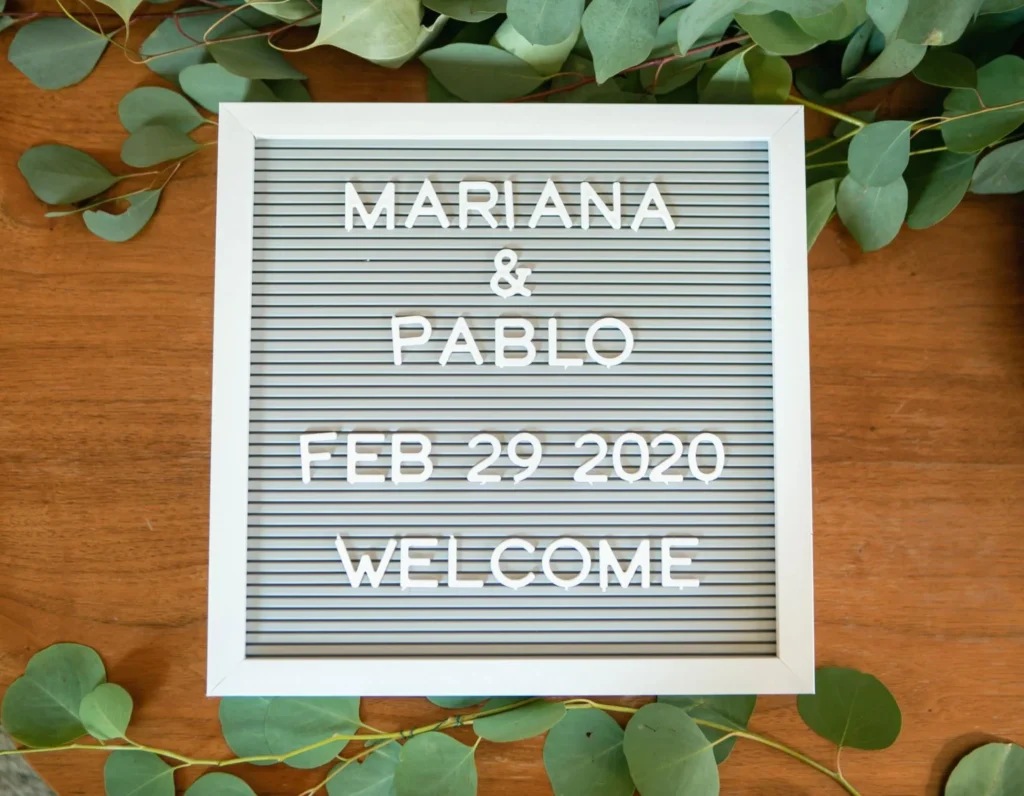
623,702,719,796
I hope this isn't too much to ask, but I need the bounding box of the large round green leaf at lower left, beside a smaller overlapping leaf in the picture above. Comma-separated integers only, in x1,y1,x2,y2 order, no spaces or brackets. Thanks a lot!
0,644,106,747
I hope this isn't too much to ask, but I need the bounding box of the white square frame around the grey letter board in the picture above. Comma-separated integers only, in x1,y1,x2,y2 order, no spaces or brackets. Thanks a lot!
207,103,814,697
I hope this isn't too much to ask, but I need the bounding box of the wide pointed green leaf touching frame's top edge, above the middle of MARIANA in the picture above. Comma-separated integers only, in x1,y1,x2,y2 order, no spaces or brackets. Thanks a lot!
420,43,545,102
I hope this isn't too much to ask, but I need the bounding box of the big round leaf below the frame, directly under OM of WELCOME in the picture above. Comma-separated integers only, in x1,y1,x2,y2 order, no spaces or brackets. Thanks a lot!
544,710,634,796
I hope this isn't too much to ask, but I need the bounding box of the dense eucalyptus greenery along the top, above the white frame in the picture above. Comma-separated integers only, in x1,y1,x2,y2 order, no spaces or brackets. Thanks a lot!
0,0,1024,244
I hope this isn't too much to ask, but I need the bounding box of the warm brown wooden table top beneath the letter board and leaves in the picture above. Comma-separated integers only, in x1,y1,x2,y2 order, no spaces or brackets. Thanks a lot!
0,26,1024,796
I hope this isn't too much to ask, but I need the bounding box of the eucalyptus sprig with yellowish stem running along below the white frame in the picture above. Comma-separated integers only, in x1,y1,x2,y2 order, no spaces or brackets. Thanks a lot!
0,643,1024,796
